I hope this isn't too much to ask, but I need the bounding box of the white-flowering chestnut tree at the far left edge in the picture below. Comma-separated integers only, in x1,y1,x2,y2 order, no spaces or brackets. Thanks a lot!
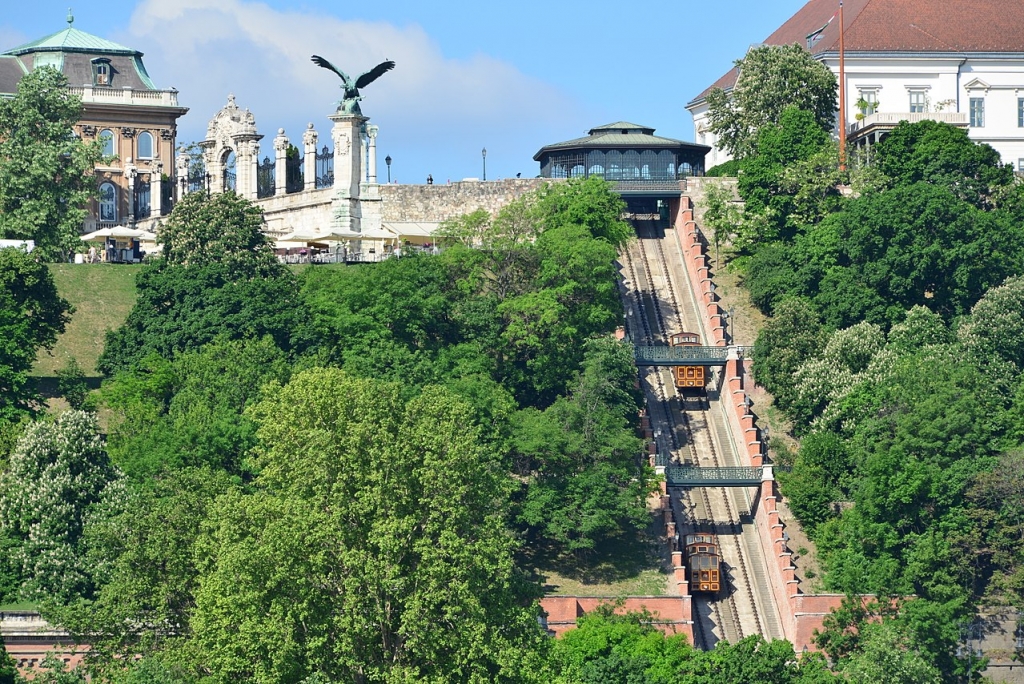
0,411,121,600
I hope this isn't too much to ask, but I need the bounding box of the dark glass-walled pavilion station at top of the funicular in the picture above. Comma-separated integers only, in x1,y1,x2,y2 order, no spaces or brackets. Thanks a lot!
534,121,711,221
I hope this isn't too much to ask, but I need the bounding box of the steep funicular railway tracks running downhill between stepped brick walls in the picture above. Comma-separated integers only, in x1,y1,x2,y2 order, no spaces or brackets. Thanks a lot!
621,222,782,648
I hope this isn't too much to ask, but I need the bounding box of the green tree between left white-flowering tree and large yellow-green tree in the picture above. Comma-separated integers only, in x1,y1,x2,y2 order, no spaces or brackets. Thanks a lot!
53,467,236,683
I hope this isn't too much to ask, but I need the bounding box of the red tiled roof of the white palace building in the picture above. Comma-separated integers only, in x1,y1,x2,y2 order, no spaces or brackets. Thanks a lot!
694,0,1024,100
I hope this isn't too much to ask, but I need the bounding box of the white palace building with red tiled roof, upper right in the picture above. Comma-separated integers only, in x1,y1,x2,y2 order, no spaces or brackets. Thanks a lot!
686,0,1024,171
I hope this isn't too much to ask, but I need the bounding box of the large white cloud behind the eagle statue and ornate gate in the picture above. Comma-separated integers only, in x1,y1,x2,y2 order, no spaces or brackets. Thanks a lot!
117,0,580,177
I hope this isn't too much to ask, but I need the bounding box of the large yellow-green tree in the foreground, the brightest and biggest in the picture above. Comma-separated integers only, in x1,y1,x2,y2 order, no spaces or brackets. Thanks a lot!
191,370,545,682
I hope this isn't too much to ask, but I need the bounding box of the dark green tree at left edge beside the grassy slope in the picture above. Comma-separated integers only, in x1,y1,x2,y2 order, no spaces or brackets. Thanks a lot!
0,249,74,423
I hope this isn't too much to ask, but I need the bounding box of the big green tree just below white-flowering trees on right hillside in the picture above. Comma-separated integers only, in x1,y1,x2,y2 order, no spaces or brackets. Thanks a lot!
815,346,1010,602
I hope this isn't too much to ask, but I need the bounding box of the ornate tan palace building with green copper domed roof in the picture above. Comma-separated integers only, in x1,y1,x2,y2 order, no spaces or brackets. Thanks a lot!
0,15,188,231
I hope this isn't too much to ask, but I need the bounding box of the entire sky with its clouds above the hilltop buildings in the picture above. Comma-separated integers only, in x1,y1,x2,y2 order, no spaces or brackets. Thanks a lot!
0,0,805,183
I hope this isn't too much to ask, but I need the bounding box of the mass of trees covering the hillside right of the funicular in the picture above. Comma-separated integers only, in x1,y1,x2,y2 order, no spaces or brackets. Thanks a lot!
709,108,1024,682
